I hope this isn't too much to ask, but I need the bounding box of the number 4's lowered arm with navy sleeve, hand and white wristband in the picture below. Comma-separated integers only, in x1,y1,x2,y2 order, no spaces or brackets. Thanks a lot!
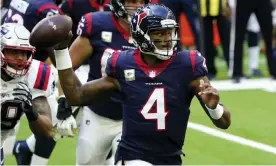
190,52,231,129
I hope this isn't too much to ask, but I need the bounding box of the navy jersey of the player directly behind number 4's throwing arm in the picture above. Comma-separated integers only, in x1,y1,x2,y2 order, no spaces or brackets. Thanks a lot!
77,12,135,120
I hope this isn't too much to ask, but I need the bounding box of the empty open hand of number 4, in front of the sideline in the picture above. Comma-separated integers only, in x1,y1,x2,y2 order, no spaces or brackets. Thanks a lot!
198,80,219,109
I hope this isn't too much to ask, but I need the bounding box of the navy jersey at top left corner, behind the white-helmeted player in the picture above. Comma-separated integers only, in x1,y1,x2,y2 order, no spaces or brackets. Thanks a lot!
5,0,62,62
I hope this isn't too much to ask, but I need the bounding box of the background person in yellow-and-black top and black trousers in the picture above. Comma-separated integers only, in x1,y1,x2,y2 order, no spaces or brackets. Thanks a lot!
200,0,231,80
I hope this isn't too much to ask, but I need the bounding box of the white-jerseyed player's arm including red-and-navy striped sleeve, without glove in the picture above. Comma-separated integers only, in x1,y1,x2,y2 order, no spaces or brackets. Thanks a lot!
25,60,55,136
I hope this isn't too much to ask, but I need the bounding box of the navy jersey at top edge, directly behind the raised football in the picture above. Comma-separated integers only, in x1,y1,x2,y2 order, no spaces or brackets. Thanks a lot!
60,0,110,45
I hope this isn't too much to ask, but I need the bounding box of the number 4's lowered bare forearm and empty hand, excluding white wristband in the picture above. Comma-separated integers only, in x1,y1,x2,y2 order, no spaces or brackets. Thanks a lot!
191,76,231,129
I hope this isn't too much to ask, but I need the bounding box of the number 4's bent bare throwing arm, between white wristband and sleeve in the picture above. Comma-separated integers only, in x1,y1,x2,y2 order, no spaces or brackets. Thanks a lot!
58,68,120,106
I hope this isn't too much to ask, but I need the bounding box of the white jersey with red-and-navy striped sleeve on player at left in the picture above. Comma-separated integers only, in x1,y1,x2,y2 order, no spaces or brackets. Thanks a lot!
1,60,55,130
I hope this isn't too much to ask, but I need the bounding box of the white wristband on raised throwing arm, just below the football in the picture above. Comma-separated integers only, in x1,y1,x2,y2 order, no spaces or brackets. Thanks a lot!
54,48,72,70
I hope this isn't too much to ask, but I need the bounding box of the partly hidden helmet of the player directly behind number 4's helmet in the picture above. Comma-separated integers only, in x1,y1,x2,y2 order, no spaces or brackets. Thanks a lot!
110,0,151,23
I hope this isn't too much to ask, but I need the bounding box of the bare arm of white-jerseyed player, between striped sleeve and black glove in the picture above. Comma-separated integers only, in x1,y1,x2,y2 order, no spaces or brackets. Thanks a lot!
29,96,53,137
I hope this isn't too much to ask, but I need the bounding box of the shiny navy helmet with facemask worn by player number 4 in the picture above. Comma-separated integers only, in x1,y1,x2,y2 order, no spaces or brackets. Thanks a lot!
131,4,179,60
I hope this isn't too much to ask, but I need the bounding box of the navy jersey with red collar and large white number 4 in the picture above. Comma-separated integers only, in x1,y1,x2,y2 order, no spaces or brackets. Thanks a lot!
106,50,207,165
